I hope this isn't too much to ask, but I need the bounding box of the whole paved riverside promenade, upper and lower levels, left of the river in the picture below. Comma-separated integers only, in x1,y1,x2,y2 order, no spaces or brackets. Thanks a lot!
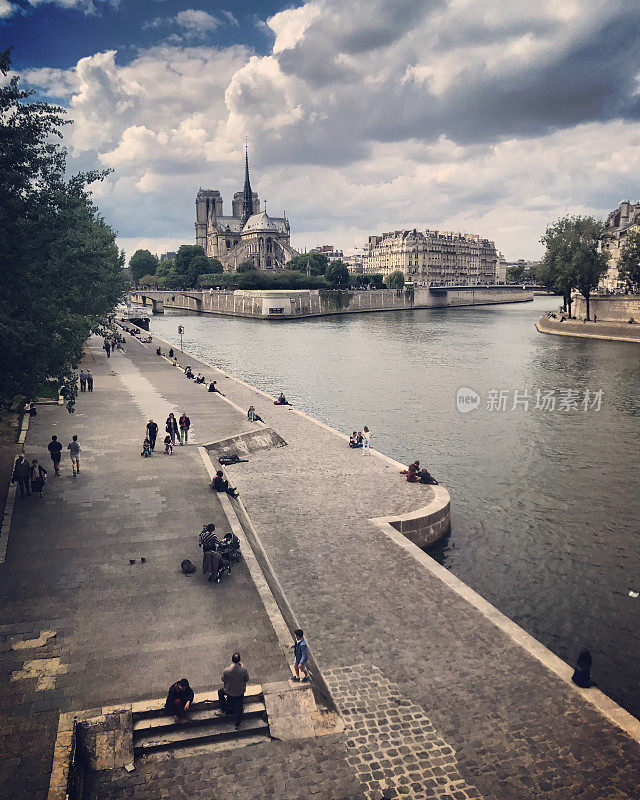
0,337,640,800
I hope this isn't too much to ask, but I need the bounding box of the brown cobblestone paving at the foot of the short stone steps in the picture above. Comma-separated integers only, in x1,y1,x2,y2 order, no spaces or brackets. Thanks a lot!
90,735,364,800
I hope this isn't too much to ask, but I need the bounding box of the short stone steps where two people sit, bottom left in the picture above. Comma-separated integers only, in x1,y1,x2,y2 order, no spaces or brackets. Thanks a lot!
132,686,269,757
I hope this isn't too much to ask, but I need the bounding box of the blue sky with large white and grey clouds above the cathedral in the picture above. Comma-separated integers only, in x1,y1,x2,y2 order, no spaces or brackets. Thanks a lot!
5,0,640,259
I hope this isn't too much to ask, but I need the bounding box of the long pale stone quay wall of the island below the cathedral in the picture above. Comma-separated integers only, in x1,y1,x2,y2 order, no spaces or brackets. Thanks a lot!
131,286,533,319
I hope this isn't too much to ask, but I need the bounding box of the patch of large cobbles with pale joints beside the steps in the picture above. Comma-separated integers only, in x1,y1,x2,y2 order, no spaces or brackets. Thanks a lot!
325,664,482,800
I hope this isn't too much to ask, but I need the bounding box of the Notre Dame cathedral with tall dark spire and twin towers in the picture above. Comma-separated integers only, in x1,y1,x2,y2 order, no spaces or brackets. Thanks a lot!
196,148,298,272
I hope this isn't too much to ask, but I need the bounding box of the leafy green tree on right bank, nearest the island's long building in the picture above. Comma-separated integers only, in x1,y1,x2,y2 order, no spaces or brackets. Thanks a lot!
537,216,608,319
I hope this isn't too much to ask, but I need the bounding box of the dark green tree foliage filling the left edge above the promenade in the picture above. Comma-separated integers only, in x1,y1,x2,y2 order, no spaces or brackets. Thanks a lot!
0,51,125,410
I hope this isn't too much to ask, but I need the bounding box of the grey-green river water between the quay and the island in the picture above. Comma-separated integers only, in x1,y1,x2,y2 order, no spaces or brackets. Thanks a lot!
151,297,640,716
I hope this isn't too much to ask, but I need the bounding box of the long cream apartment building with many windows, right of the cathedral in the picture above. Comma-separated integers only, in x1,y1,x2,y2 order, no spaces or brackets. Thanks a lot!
362,228,499,286
